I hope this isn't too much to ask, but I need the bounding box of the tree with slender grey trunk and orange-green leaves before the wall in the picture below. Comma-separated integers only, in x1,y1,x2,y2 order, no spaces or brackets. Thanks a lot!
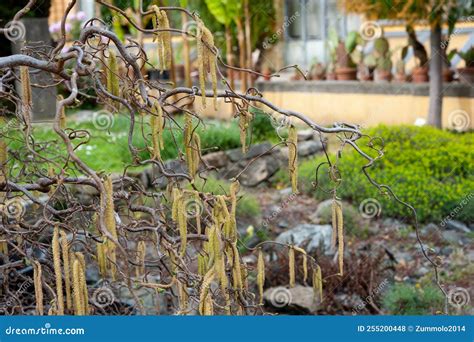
344,0,474,128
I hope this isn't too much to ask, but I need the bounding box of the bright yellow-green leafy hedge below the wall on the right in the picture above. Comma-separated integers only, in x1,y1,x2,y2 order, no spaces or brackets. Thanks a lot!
279,126,474,223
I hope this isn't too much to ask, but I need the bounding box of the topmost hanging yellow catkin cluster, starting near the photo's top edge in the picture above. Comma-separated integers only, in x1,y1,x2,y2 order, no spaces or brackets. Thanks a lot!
152,5,171,71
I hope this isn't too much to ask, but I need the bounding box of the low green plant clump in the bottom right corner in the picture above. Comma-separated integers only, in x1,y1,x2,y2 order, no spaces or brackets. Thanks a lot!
382,283,444,315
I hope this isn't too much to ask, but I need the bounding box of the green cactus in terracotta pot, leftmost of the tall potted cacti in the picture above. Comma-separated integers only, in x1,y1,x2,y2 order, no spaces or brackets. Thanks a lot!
335,31,360,81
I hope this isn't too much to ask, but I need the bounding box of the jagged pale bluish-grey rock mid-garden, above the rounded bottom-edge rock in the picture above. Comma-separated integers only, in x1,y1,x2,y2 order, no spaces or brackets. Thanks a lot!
276,223,333,254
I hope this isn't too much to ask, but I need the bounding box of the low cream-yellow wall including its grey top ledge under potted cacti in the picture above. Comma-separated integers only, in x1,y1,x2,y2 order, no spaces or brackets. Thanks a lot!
198,81,474,129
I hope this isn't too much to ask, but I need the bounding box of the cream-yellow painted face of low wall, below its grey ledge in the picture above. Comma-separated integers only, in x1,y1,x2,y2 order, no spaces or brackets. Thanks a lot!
201,92,474,129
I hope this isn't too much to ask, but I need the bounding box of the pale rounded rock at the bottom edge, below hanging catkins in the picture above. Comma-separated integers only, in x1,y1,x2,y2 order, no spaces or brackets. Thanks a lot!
263,285,318,314
